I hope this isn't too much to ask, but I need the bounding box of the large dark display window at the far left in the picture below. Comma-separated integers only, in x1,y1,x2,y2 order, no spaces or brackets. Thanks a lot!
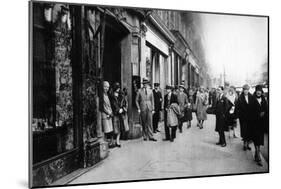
31,3,74,164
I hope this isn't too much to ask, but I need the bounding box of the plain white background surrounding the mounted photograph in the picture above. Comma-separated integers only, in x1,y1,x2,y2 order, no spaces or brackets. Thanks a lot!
0,0,281,189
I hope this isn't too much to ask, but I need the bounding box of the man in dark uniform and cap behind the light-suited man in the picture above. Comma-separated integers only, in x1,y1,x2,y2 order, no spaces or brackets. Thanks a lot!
152,83,163,133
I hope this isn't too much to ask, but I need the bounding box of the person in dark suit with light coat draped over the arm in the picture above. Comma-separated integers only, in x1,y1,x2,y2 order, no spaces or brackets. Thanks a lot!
167,95,181,142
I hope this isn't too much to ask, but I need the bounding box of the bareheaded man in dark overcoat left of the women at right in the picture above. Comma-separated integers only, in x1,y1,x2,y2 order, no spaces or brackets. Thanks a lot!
215,86,230,147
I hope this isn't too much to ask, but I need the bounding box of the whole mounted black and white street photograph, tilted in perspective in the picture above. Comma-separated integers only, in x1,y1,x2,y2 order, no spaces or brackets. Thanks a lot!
28,0,270,188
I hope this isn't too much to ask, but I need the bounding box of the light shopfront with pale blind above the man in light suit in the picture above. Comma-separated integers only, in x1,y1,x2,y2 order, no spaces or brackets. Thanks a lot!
141,14,175,90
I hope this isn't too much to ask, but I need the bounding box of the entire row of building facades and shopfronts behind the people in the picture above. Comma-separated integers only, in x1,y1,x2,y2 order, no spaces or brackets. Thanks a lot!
30,2,207,186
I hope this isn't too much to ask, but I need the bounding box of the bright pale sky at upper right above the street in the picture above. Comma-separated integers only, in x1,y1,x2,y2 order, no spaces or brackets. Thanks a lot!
201,14,268,85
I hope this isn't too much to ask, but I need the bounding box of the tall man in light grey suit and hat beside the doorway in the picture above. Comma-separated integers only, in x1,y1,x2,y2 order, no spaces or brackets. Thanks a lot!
136,78,157,141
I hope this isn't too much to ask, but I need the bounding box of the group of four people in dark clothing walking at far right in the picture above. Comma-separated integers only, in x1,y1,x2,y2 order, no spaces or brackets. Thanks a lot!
213,84,268,166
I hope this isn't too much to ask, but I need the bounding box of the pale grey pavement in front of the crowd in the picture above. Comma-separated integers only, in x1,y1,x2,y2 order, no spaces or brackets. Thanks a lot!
69,115,268,184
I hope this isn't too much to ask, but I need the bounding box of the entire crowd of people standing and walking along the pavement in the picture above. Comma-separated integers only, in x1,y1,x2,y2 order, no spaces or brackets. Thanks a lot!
100,78,269,166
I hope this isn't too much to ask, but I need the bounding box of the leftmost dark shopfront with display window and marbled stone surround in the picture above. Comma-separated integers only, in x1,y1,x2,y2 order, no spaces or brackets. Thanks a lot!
31,3,83,186
